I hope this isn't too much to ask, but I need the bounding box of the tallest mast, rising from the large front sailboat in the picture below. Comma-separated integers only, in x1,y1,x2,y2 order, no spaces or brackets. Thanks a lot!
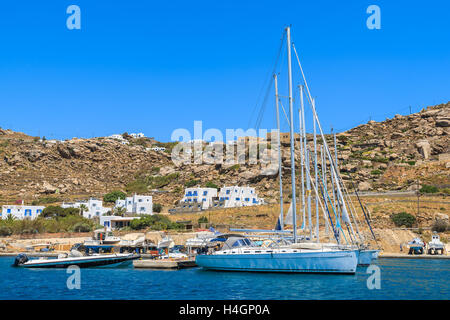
286,27,297,243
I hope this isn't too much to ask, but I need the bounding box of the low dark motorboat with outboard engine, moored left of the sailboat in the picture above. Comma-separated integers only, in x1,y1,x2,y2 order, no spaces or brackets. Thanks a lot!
13,250,140,268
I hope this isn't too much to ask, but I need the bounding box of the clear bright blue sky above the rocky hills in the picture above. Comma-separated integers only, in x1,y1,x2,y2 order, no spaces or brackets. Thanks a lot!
0,0,450,141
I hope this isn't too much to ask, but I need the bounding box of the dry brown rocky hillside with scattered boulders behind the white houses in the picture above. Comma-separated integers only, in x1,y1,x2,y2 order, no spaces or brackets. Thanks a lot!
0,103,450,209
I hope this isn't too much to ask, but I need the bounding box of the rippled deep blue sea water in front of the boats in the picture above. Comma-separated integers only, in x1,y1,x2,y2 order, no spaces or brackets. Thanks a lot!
0,257,450,300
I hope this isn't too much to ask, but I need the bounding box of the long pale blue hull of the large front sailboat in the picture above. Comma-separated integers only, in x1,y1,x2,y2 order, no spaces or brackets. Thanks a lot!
196,251,358,274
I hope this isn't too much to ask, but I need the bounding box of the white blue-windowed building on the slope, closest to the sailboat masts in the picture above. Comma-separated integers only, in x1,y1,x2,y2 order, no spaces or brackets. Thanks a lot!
219,186,264,208
